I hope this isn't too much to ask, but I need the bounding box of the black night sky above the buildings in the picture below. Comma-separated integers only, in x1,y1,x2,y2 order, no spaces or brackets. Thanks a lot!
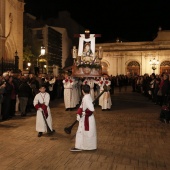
25,0,170,42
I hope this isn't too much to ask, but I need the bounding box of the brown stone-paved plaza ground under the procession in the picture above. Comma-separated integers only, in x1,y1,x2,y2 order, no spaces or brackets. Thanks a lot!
0,87,170,170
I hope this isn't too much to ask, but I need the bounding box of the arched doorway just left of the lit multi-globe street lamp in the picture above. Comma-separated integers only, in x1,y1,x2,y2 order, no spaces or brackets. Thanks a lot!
126,61,140,76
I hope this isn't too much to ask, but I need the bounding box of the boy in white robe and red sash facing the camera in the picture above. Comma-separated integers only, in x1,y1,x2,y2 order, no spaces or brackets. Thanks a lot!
33,85,54,137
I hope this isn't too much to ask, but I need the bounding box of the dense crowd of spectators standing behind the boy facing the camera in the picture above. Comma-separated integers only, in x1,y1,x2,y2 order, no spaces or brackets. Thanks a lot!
0,72,63,121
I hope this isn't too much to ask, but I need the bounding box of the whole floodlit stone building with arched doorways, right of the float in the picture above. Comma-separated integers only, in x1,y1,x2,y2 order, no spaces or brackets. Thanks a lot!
96,30,170,76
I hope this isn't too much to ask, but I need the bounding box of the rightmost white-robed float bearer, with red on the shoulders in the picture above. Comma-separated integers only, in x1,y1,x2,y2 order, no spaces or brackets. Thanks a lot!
98,75,112,111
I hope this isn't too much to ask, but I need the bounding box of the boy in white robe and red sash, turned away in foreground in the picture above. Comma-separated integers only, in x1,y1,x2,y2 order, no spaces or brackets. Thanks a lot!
70,84,97,152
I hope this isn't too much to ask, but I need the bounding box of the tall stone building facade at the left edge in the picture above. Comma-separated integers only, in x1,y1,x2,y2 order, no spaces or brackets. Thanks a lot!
0,0,24,72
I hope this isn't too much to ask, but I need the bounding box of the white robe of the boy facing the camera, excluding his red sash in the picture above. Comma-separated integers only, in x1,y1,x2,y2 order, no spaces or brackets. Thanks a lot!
33,92,53,132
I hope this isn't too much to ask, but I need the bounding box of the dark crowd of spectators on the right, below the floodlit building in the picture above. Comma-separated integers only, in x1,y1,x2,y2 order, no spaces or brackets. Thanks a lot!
107,73,170,106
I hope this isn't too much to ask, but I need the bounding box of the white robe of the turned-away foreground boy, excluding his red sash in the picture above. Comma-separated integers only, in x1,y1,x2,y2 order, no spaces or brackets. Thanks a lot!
75,94,97,150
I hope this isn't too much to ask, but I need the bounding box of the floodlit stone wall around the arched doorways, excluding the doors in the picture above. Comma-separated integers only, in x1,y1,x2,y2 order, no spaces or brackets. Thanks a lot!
96,33,170,76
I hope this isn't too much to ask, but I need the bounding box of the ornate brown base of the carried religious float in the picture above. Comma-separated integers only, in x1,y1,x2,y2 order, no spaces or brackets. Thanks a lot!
72,65,102,77
